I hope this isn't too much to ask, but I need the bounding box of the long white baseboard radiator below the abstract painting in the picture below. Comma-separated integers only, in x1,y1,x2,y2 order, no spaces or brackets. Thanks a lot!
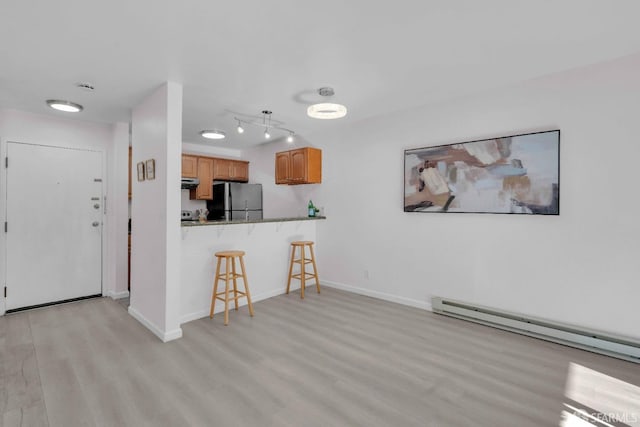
431,297,640,363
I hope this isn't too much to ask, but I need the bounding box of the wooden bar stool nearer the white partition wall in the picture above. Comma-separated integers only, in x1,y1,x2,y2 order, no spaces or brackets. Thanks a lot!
209,251,253,325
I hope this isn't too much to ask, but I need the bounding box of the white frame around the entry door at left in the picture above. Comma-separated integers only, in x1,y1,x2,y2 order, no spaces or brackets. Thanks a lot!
0,138,109,316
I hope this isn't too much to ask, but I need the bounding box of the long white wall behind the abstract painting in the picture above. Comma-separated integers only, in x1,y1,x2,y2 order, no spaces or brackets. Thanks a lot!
264,56,640,338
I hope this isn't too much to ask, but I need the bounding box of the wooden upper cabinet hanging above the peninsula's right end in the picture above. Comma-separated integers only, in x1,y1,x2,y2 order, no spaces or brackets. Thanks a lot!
275,147,322,185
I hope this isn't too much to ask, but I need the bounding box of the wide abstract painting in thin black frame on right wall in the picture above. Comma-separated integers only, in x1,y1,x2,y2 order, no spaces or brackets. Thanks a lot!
404,130,560,215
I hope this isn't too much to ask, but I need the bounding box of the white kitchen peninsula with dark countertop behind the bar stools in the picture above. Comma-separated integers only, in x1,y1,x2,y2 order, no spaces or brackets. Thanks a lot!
180,217,325,323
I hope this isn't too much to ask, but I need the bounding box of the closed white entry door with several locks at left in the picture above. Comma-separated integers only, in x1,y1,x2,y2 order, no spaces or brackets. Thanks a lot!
6,142,103,310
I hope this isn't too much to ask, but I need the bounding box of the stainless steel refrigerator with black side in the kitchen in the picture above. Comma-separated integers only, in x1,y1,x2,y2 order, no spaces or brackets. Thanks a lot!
207,182,262,221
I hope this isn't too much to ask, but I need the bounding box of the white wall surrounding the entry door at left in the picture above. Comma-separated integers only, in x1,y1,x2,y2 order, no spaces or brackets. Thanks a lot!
0,109,126,314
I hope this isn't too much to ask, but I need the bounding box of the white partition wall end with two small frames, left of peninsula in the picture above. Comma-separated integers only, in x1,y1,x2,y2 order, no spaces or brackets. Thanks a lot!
129,82,182,341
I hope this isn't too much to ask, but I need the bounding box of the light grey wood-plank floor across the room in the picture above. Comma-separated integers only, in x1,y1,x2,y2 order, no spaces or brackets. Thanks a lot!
0,287,640,427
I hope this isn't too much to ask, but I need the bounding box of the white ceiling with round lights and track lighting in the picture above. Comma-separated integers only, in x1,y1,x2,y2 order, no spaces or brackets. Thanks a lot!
0,0,640,149
